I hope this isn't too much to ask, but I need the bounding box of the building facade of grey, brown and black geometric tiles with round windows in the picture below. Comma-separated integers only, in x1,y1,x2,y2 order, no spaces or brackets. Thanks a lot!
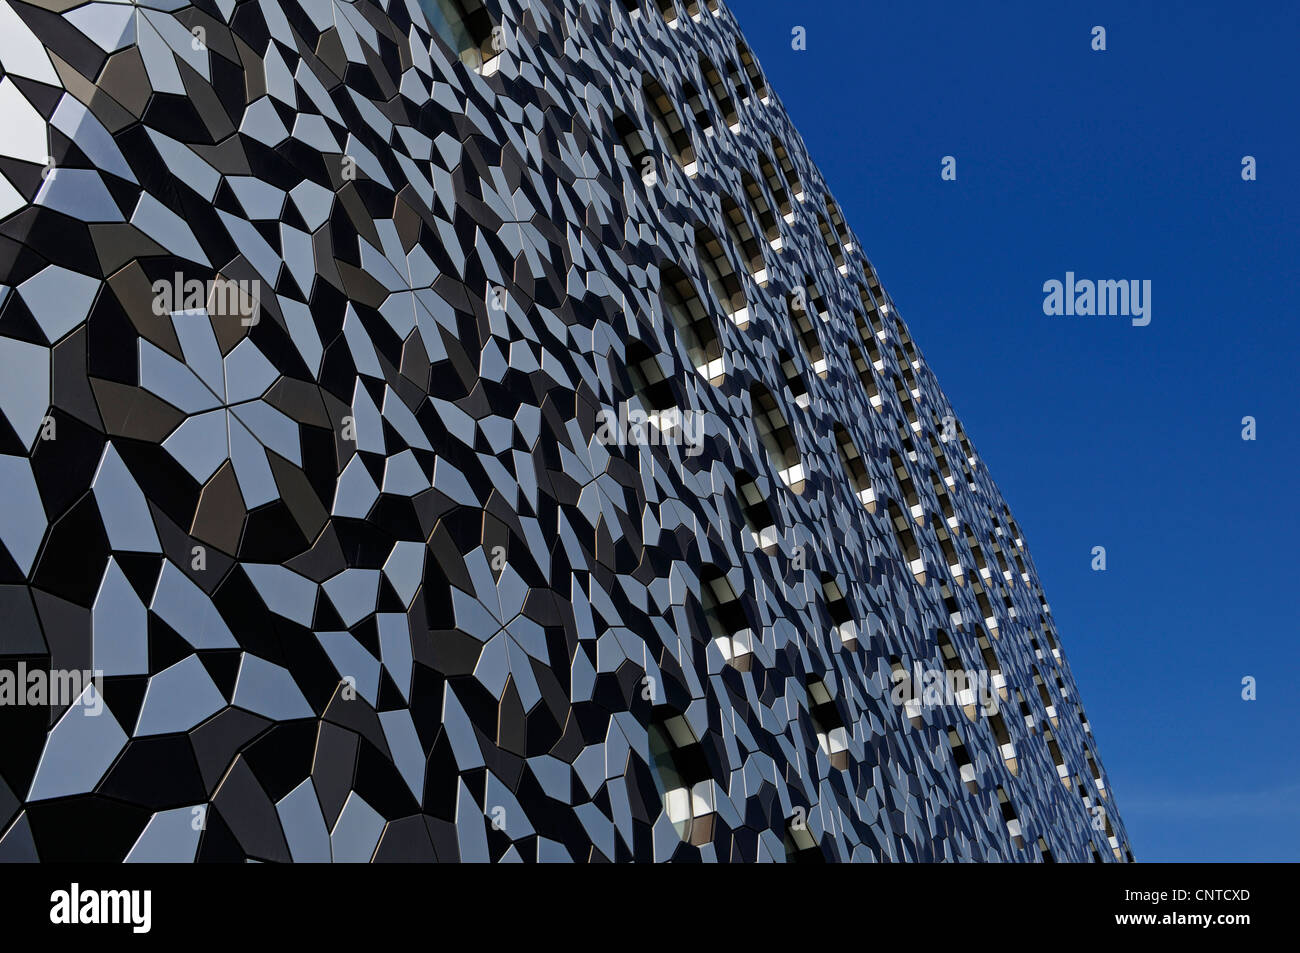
0,0,1131,861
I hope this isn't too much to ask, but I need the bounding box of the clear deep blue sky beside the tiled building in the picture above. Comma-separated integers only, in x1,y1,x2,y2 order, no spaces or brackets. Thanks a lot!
729,0,1300,861
